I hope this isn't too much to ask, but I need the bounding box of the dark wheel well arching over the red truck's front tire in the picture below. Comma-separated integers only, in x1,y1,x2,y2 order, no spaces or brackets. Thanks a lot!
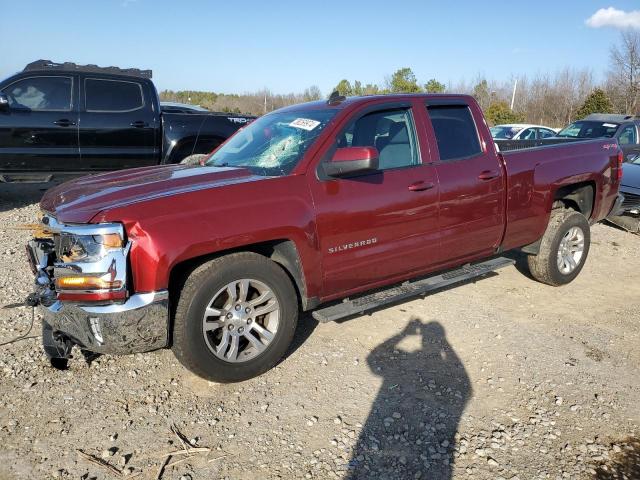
169,239,315,316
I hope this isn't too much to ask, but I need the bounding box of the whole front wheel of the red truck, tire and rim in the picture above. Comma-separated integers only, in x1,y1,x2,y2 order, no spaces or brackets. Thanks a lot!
172,252,298,383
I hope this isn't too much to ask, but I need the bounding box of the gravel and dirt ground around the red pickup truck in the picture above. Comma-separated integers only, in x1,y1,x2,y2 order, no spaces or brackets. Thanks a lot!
0,185,640,480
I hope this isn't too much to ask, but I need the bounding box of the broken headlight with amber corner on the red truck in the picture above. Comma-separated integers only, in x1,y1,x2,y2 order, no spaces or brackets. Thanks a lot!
56,233,124,263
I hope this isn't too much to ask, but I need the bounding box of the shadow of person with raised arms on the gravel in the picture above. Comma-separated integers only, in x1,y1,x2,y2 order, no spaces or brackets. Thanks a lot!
347,317,472,480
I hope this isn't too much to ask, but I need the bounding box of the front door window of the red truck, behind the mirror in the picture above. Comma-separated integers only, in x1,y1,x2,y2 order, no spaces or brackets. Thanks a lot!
338,109,420,170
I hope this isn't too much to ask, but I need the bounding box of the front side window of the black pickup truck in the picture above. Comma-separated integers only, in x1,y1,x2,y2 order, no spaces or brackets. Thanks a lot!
3,77,73,112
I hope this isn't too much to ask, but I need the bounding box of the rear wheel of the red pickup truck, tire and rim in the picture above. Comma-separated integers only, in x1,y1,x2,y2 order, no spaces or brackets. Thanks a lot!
527,208,591,286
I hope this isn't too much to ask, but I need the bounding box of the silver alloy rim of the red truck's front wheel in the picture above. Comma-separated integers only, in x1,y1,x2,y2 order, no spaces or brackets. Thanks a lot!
202,278,280,363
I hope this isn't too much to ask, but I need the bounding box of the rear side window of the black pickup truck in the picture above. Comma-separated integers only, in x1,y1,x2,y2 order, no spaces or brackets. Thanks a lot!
84,78,144,112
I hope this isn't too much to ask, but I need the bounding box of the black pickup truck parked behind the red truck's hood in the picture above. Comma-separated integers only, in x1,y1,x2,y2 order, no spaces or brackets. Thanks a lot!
0,60,254,182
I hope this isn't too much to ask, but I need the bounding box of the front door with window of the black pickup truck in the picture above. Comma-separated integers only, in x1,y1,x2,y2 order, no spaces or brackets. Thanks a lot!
0,74,80,172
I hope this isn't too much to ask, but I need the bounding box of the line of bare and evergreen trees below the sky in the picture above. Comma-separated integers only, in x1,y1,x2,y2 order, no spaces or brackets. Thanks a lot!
160,30,640,127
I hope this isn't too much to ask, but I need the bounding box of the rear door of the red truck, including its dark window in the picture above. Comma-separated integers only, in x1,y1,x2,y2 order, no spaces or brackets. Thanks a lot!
427,100,505,262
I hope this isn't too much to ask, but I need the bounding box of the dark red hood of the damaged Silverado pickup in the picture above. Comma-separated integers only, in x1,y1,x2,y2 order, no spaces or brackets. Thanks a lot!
40,165,267,223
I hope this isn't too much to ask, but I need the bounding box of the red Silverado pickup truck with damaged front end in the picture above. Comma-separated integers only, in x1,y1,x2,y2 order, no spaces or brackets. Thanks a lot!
28,95,622,382
